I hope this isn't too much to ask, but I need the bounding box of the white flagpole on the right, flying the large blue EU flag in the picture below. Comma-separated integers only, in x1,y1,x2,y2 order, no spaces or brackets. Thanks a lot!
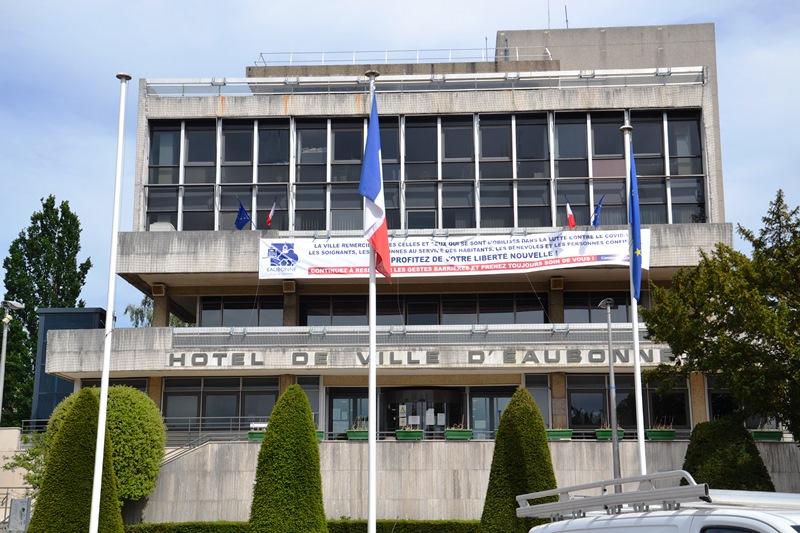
612,120,647,475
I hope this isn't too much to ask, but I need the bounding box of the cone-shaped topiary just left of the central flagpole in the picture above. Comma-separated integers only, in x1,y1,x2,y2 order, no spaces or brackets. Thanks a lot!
248,385,328,533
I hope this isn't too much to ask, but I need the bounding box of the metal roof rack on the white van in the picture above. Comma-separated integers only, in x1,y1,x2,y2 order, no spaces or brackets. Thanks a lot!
517,470,711,521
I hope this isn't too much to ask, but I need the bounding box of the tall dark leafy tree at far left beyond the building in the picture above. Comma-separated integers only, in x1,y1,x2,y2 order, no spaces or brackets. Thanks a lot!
2,195,92,426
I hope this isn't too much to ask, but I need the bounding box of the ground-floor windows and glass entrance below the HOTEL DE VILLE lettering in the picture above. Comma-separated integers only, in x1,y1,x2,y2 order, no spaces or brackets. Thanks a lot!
82,374,755,438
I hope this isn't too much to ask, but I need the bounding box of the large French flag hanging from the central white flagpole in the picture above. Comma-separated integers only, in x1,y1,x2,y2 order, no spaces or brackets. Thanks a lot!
358,94,392,280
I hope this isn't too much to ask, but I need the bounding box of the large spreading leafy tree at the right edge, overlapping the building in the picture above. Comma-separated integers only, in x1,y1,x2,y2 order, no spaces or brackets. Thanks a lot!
642,191,800,440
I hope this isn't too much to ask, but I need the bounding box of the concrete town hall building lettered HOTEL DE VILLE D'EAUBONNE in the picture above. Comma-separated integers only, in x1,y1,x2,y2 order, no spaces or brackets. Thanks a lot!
40,24,784,519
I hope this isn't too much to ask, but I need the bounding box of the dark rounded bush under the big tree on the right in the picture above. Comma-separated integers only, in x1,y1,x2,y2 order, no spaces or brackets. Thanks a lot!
683,418,775,492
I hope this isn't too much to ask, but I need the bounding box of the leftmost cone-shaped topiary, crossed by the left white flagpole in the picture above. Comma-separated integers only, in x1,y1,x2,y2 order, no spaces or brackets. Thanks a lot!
28,389,124,533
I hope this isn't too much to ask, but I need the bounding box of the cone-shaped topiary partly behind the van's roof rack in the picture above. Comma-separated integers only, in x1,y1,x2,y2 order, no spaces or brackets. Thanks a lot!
481,387,557,533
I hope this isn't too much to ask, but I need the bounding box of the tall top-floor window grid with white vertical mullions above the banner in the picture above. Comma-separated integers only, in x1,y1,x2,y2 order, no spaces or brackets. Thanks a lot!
145,110,706,231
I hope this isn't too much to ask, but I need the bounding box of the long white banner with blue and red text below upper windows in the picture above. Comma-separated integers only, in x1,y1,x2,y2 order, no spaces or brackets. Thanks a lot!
258,229,650,279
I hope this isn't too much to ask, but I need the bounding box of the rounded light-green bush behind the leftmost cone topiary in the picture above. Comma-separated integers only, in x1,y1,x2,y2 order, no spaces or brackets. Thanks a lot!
3,385,166,501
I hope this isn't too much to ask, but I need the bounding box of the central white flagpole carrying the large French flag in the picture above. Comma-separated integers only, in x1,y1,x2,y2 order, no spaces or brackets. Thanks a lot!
367,72,378,533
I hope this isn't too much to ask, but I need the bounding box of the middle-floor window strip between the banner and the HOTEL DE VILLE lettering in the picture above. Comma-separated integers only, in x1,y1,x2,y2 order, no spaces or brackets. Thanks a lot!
199,291,630,327
